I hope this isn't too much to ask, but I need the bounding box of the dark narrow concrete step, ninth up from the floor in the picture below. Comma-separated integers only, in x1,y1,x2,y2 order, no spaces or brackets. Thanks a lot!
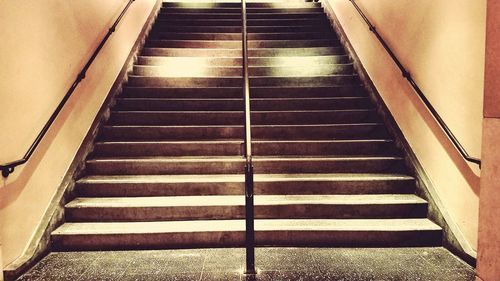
122,85,366,98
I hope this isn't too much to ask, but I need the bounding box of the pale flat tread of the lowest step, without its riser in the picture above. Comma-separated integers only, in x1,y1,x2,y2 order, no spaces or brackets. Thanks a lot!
52,219,441,235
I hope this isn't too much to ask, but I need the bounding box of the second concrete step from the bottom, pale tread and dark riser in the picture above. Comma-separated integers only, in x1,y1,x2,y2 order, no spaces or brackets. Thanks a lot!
65,193,427,222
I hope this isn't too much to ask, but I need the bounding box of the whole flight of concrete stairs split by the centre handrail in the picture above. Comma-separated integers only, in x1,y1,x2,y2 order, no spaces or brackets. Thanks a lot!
52,2,442,250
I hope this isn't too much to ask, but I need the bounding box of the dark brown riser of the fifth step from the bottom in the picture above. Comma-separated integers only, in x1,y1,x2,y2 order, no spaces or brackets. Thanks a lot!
93,141,395,157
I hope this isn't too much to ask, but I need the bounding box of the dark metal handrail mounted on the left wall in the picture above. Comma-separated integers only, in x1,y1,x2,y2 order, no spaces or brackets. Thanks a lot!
0,0,135,177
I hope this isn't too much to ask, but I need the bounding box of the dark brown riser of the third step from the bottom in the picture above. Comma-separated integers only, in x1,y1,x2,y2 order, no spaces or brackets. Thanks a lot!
75,180,415,197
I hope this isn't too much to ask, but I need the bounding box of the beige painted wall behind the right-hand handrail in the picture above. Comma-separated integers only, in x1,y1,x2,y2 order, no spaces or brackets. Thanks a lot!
329,0,486,250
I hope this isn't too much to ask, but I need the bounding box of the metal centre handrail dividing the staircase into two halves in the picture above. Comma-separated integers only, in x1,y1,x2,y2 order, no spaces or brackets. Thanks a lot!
241,0,255,274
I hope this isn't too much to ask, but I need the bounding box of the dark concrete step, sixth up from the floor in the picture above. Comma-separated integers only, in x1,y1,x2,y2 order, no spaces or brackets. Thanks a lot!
98,123,388,141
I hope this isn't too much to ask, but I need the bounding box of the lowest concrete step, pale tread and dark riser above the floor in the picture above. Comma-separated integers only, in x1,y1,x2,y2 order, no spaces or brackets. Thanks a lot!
52,219,442,250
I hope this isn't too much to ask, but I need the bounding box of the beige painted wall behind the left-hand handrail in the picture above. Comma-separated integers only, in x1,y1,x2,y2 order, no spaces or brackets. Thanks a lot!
0,0,156,265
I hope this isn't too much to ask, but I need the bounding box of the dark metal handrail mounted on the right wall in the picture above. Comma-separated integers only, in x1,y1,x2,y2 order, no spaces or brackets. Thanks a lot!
349,0,481,167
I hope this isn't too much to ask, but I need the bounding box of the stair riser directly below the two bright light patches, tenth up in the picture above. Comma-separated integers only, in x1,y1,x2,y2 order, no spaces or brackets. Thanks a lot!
128,75,359,88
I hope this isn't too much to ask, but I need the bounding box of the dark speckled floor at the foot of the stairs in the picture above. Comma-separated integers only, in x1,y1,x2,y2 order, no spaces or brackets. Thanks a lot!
18,248,474,281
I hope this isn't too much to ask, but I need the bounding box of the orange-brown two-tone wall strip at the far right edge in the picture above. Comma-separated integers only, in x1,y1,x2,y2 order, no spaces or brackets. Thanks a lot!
477,0,500,281
